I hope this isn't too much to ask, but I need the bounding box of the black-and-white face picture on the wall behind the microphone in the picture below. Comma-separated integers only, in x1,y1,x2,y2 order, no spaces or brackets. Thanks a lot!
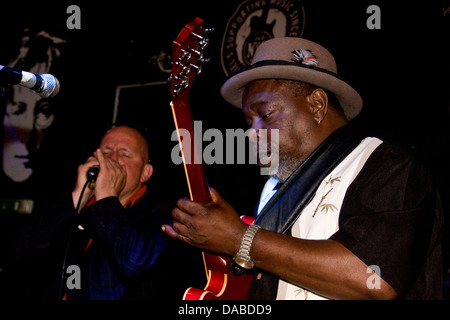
1,29,66,198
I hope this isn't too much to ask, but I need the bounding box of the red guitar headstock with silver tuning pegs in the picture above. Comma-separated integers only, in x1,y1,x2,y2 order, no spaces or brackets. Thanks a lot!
170,18,212,99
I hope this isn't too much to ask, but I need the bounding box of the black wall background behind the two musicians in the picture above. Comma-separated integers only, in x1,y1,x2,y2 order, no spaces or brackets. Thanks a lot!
0,0,450,298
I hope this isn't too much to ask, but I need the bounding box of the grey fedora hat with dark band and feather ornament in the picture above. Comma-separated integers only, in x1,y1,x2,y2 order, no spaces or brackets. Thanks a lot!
220,37,362,120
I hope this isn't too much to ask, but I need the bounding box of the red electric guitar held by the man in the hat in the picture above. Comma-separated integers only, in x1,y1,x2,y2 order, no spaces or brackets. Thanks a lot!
170,18,253,300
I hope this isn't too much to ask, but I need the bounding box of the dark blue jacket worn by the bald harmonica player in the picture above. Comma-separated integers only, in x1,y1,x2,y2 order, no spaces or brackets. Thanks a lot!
5,190,173,299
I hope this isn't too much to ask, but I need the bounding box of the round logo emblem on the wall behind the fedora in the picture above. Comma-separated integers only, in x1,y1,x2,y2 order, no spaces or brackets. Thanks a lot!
221,0,305,76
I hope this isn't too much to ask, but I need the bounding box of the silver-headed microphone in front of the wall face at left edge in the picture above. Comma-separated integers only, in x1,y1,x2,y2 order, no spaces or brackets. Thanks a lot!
0,65,59,98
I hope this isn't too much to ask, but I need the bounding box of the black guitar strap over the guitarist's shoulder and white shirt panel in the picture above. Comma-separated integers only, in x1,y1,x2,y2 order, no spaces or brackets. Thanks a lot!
248,125,364,300
